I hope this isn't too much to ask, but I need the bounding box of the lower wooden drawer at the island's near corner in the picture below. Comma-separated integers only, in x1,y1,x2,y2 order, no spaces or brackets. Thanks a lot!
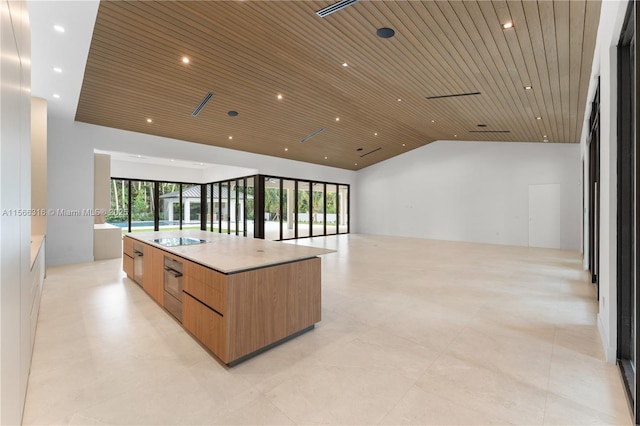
182,294,229,363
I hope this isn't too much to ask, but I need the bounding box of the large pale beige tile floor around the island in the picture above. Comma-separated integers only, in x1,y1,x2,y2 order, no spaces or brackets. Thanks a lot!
24,234,631,425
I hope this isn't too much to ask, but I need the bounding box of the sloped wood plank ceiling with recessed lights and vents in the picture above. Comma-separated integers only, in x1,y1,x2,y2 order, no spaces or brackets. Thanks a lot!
76,0,600,170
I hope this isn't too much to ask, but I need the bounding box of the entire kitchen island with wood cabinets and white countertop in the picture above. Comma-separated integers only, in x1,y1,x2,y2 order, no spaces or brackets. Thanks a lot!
123,231,332,366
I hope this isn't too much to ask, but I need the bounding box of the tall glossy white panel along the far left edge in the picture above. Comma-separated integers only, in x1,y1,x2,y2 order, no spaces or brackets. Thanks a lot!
0,0,33,425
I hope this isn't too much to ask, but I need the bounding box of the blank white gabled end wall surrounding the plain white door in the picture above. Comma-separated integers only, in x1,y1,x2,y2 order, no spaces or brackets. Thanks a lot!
354,141,581,250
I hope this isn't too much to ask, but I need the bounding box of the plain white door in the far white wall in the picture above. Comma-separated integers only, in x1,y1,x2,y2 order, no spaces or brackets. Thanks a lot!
529,183,560,248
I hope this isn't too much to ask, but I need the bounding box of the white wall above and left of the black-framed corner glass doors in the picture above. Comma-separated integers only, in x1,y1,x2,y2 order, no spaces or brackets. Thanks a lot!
47,118,355,265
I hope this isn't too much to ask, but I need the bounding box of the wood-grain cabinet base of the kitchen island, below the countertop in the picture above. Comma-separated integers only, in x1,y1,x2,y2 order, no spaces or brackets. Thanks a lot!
123,233,329,365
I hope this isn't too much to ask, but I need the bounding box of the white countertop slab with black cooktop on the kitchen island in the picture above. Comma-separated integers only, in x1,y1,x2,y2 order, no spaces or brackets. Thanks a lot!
125,230,334,274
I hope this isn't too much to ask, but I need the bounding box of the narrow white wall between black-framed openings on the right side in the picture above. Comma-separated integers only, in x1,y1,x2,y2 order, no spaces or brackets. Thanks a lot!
581,0,628,363
